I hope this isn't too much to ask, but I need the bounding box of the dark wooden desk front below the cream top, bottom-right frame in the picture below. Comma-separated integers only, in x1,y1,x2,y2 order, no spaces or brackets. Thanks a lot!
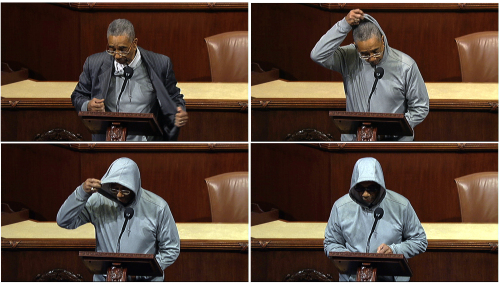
251,241,498,282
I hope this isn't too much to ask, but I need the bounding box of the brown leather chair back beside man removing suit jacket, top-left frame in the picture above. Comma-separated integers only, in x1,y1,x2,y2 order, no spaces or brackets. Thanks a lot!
205,31,248,82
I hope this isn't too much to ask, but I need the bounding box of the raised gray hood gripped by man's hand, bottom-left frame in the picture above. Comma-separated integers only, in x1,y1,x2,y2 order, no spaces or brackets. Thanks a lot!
101,157,141,202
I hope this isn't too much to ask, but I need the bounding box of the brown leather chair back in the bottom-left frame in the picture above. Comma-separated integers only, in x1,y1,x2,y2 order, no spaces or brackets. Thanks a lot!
205,172,248,223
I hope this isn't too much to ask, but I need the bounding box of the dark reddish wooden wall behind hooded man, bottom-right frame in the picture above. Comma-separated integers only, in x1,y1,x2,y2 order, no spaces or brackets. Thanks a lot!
251,143,498,222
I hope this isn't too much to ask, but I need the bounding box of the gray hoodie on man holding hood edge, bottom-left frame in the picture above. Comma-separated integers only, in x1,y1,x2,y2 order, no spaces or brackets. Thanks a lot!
57,158,180,281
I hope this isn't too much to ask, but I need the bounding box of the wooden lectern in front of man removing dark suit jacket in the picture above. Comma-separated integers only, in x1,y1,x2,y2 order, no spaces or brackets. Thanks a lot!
78,111,163,141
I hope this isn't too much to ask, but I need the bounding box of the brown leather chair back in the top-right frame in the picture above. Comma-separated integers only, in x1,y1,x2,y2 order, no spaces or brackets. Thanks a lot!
455,31,498,82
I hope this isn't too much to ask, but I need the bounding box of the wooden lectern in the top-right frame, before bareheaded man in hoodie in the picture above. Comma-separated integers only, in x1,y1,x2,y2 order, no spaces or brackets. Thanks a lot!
329,111,413,141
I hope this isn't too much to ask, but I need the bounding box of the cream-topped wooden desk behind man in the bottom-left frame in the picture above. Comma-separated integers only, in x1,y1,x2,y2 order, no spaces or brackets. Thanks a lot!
2,221,248,282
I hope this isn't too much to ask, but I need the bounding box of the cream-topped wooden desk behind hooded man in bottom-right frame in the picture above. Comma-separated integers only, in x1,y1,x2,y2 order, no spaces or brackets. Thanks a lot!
251,221,498,282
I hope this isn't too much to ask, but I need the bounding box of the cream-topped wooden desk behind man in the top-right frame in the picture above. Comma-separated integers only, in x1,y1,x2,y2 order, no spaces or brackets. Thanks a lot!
252,80,498,141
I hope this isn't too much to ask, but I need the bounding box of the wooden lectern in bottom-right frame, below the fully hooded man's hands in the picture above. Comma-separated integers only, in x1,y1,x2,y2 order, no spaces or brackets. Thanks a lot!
328,252,413,282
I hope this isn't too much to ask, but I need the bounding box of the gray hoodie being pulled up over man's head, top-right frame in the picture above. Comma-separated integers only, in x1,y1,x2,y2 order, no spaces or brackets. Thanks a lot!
311,14,429,141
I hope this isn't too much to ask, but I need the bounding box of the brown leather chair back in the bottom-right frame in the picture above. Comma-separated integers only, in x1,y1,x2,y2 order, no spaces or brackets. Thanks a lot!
455,172,498,223
